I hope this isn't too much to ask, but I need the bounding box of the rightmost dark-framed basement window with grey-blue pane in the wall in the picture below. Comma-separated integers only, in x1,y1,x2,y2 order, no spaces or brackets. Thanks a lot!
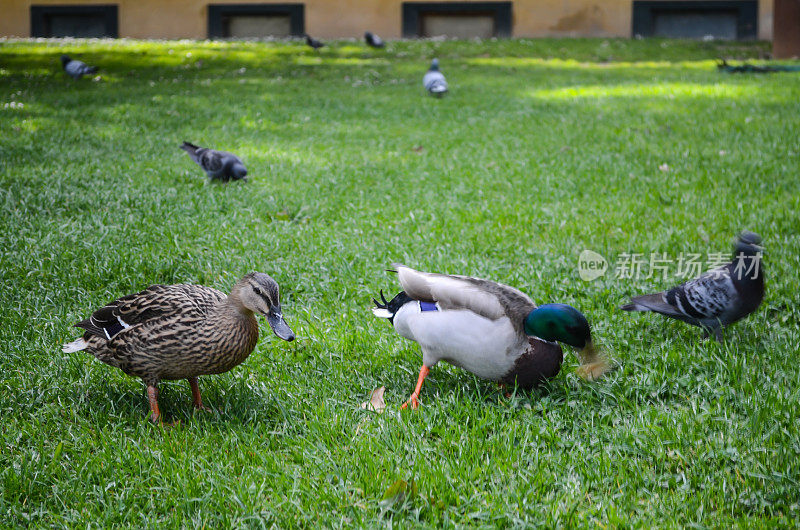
633,0,758,40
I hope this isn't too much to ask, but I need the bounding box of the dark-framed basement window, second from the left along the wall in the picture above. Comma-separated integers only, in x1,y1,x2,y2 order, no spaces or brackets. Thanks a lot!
208,4,305,39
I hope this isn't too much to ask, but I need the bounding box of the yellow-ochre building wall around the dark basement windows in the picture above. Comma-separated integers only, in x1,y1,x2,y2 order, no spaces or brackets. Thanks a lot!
0,0,773,40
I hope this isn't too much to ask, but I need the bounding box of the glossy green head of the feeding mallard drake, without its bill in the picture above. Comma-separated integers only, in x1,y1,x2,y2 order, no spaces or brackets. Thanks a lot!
525,304,592,349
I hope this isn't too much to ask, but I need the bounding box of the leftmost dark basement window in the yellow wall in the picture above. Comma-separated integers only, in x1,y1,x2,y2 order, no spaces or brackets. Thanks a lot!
31,5,119,38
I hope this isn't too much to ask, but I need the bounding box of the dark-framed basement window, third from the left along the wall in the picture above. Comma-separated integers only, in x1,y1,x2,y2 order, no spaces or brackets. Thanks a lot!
403,2,511,38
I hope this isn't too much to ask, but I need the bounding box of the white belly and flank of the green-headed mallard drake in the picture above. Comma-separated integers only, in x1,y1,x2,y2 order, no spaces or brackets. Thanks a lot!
394,301,527,380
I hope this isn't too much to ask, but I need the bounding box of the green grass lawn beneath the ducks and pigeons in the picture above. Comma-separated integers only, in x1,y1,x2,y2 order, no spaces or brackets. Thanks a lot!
0,36,800,528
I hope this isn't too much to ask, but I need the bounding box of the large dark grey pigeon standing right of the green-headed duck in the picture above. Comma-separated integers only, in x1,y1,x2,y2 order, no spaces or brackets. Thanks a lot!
620,231,764,341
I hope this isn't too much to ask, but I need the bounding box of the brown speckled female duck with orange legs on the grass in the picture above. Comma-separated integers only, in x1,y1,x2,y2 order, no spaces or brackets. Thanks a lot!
63,272,294,422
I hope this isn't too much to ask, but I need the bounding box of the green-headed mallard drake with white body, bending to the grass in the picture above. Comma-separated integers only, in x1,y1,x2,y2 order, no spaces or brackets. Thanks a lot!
372,265,609,408
